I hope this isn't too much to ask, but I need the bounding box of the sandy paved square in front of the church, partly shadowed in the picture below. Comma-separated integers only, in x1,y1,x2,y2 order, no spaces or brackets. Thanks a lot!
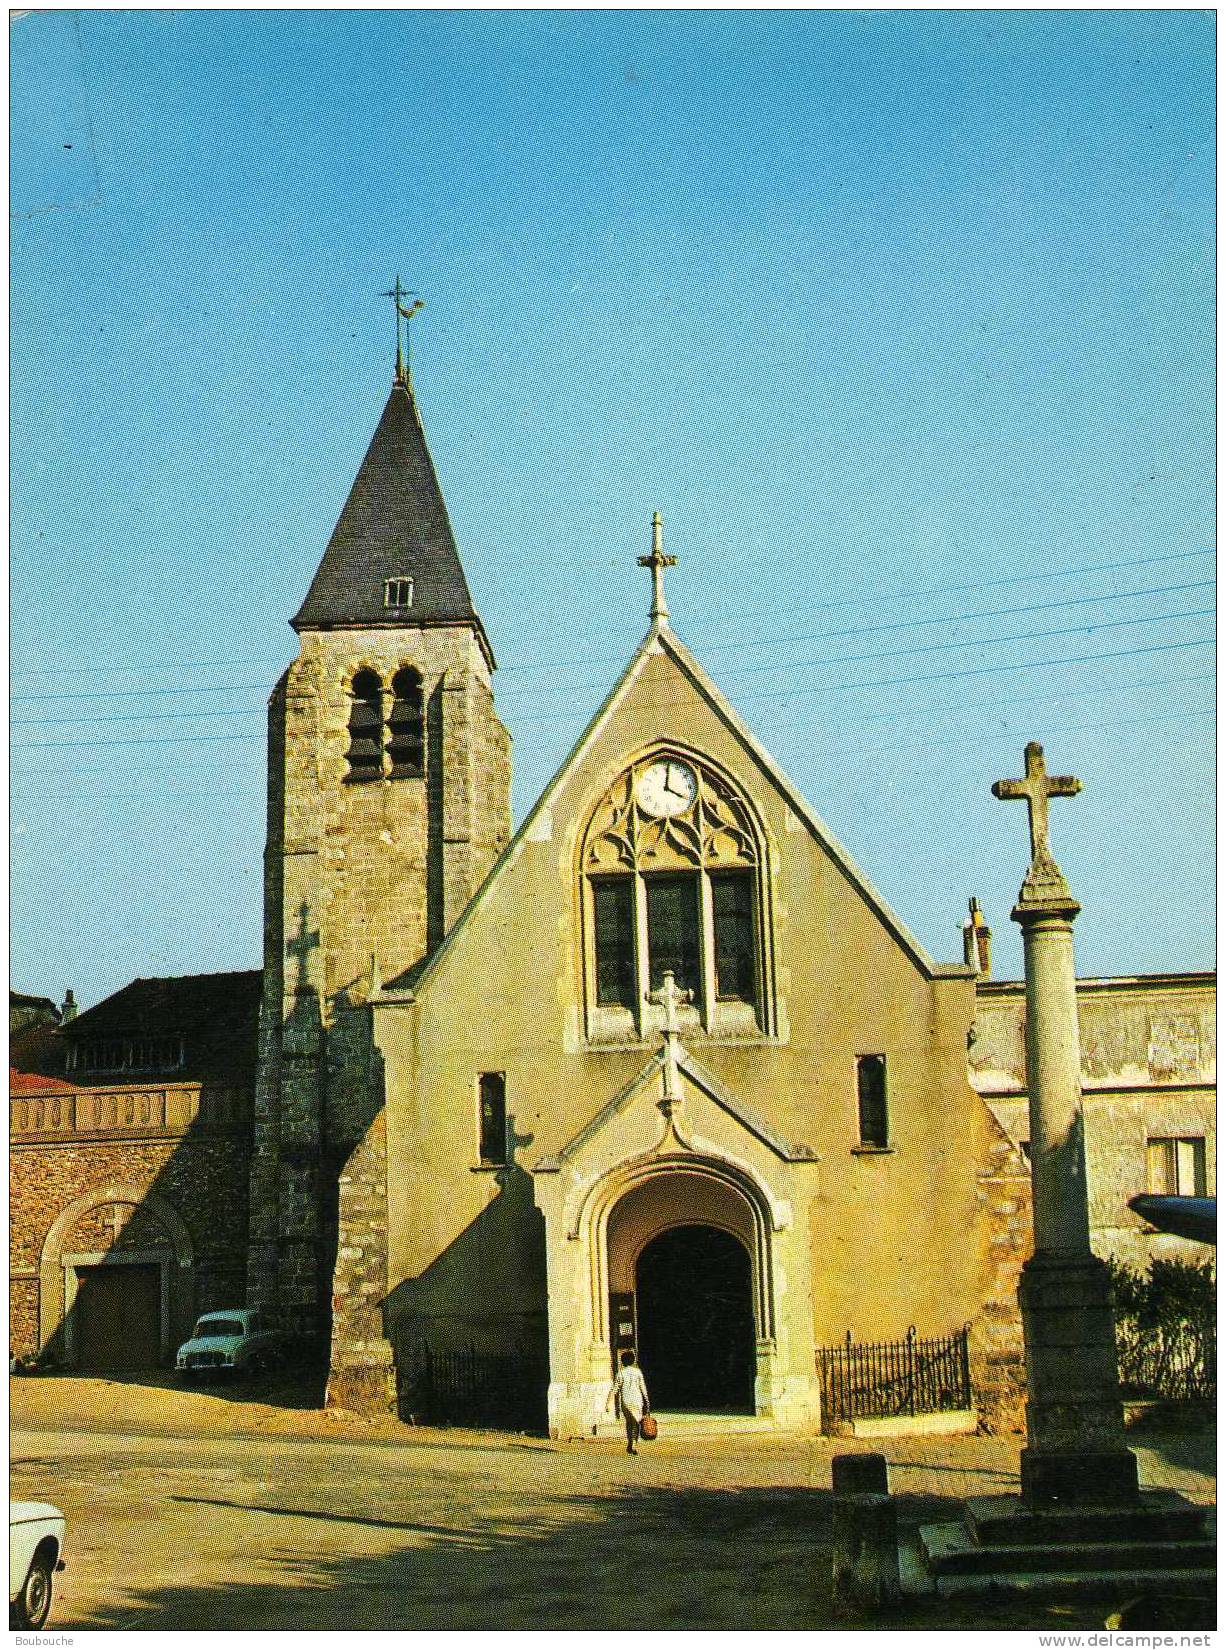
12,1376,1213,1630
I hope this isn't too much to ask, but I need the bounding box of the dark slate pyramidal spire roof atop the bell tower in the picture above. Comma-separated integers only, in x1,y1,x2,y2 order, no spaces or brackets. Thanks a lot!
290,378,488,648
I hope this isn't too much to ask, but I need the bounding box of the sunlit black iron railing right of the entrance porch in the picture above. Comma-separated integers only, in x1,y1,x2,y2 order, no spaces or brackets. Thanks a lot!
817,1325,970,1421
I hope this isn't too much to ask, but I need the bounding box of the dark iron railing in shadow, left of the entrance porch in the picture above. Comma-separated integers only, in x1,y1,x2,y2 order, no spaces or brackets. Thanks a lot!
399,1345,549,1431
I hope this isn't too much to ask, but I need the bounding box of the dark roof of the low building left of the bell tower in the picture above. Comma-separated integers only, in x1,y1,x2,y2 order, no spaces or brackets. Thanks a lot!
8,969,264,1087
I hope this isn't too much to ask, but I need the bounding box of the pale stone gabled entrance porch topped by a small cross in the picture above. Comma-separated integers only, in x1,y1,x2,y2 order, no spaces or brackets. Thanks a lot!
533,1053,820,1437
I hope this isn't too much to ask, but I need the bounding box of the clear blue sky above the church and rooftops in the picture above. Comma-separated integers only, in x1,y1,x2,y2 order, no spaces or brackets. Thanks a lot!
12,10,1214,1003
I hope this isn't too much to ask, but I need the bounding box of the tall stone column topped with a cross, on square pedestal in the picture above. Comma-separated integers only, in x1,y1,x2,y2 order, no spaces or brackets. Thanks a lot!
992,741,1137,1511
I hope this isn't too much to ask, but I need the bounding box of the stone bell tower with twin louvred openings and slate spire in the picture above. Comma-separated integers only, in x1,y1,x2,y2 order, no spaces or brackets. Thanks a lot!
248,360,510,1335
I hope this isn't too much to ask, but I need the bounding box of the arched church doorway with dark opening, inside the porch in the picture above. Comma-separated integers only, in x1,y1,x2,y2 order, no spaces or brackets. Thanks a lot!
607,1170,761,1416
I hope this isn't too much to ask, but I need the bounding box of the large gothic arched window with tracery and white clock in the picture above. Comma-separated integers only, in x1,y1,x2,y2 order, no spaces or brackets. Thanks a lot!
582,751,772,1038
